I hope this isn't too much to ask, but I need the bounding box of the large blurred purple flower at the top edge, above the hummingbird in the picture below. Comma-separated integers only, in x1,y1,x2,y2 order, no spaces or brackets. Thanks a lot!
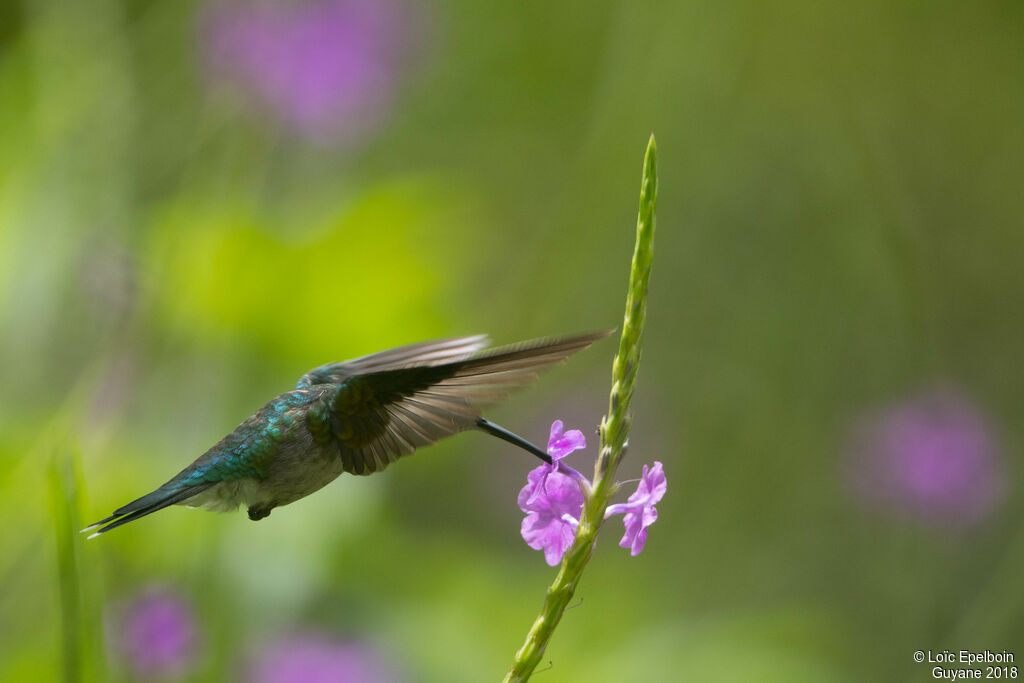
205,0,409,139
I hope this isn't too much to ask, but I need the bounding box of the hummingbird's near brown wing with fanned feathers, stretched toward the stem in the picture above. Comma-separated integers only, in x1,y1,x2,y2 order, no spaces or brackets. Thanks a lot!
306,330,611,474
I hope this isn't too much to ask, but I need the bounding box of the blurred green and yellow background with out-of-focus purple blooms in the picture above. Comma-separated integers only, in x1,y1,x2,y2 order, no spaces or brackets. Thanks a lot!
0,0,1024,683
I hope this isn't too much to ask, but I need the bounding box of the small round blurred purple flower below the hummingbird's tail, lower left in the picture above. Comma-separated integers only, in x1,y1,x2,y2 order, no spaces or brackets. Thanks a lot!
112,588,197,677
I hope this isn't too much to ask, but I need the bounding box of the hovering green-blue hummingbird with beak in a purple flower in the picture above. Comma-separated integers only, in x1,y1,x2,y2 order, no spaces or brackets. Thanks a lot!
82,330,612,539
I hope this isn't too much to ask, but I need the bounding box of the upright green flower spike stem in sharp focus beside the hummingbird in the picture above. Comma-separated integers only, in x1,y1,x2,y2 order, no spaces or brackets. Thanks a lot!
505,135,657,683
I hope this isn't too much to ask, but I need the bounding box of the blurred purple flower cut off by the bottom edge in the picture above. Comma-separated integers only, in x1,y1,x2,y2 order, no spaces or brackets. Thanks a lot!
249,633,398,683
